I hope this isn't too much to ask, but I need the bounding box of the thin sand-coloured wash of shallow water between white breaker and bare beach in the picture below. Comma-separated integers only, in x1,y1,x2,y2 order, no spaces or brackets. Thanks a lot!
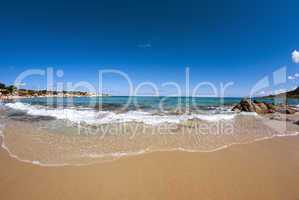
2,99,298,166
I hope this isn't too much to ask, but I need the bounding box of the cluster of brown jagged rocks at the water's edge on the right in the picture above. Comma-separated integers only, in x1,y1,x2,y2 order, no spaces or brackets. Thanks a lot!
232,99,297,114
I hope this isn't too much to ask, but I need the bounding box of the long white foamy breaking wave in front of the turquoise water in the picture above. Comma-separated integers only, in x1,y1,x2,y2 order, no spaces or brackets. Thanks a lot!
6,102,241,125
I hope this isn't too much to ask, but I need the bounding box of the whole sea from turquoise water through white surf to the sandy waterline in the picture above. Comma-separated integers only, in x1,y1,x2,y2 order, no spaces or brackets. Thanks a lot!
0,97,299,166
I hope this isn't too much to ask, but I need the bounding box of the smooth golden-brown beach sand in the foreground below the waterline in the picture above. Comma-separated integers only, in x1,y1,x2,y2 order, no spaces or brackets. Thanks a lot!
0,136,299,200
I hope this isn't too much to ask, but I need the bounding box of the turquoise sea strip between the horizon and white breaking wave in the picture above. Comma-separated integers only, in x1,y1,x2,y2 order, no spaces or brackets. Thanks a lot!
17,96,299,110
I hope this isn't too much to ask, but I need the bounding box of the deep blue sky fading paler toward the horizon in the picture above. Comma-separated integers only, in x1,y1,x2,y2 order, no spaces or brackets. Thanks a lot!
0,0,299,96
